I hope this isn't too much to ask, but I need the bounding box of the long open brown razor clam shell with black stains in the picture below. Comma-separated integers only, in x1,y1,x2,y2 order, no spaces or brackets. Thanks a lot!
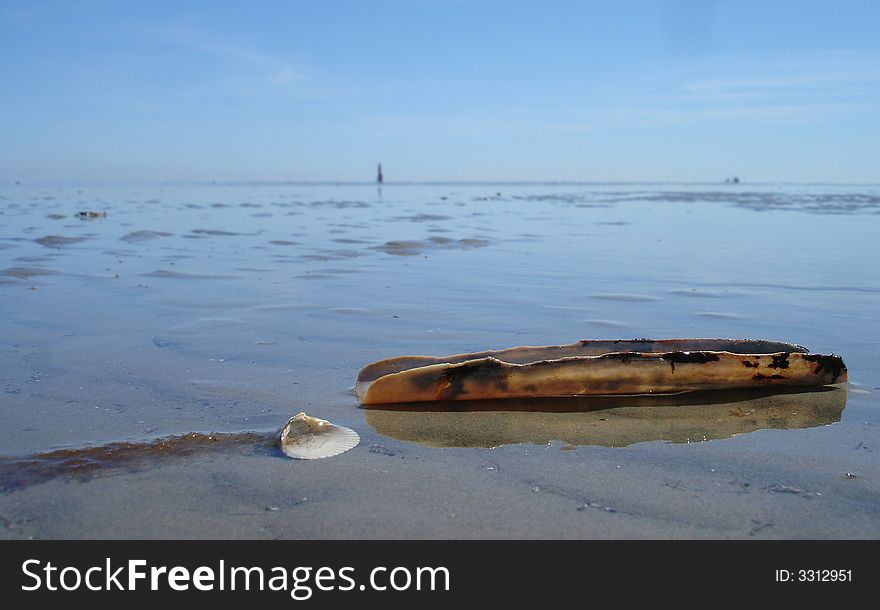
356,339,847,404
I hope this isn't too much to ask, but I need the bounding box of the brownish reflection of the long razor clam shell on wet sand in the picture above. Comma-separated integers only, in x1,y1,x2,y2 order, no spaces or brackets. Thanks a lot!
364,388,846,447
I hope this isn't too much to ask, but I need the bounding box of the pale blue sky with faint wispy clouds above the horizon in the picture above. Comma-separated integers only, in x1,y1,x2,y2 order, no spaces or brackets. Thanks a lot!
0,0,880,183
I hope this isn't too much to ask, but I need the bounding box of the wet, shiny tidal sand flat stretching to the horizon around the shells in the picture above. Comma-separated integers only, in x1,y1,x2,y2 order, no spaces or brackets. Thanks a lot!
0,184,880,538
